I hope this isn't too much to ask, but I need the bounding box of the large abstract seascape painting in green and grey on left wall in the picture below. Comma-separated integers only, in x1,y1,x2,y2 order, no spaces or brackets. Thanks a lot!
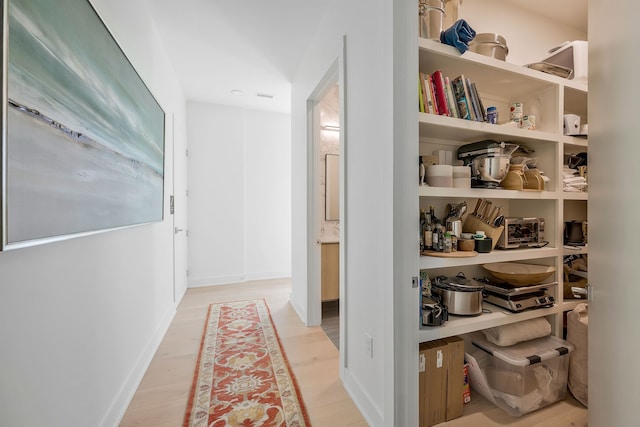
2,0,165,249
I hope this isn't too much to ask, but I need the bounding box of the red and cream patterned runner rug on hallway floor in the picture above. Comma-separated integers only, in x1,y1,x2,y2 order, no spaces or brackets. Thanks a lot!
183,300,310,427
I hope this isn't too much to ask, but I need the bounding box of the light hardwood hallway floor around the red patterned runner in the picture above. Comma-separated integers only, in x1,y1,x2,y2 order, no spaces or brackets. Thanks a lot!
120,279,367,427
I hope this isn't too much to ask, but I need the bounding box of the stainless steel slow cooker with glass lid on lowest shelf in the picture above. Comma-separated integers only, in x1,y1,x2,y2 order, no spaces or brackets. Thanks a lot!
432,273,484,316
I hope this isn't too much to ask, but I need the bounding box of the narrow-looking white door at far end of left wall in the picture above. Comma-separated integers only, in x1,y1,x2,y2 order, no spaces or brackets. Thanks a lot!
170,114,189,304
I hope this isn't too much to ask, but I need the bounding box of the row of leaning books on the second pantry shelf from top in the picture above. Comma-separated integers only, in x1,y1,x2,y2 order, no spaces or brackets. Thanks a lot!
418,70,487,122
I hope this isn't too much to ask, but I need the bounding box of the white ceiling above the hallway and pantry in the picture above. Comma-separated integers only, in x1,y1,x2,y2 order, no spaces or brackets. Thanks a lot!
147,0,587,113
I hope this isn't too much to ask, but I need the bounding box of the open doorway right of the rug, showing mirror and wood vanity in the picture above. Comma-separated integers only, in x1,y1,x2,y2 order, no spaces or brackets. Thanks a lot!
307,60,345,355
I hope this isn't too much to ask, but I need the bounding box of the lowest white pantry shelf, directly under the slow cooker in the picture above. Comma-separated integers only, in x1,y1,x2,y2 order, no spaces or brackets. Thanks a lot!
418,302,560,342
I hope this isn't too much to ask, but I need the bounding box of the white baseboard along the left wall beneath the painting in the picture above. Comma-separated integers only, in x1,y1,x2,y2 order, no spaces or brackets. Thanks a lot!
99,304,176,427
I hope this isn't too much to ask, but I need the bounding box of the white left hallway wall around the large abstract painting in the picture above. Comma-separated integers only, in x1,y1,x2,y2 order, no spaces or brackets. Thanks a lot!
0,0,185,427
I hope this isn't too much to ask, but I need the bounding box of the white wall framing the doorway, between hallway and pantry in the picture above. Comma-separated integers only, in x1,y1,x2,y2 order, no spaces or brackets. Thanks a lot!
291,0,394,425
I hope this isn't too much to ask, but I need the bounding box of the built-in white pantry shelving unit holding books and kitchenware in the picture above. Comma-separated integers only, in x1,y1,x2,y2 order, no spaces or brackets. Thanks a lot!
417,39,587,342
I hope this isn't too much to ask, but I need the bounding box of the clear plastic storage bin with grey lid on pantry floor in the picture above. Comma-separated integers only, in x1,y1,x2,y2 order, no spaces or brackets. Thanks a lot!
465,332,573,417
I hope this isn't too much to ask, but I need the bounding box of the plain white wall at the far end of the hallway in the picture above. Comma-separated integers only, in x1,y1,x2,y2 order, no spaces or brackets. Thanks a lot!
187,101,291,286
